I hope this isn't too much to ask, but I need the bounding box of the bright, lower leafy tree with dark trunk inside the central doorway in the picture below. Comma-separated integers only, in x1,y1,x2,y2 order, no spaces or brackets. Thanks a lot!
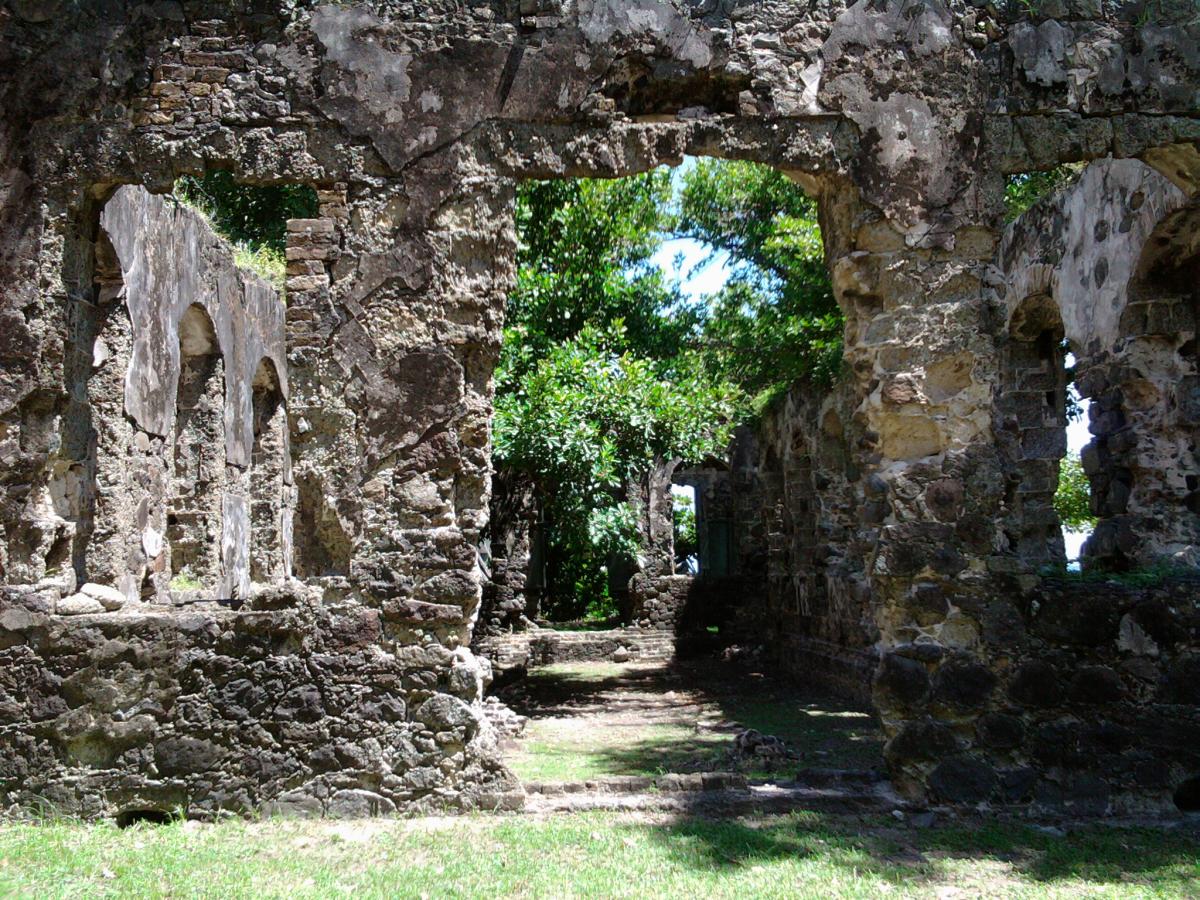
493,320,737,618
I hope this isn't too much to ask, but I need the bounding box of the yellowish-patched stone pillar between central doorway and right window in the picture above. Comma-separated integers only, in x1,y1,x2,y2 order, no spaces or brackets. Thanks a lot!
829,192,1020,798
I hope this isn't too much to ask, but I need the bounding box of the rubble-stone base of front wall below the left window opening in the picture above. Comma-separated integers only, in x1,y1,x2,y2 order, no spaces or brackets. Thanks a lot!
0,588,520,817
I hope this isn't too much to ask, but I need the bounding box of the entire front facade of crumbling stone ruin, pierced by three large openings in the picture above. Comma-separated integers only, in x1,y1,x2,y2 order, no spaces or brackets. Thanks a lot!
0,0,1200,815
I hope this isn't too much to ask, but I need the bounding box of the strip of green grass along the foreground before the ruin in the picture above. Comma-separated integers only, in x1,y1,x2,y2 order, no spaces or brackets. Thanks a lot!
0,814,1200,899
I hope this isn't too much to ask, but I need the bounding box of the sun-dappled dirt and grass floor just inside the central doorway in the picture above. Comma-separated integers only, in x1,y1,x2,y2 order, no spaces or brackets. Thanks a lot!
502,661,881,782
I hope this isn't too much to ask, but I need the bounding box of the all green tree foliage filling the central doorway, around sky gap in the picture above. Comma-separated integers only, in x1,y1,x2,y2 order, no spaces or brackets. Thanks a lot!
494,161,842,618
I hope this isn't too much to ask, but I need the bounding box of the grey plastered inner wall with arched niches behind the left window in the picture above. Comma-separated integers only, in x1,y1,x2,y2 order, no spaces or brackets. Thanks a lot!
21,186,292,610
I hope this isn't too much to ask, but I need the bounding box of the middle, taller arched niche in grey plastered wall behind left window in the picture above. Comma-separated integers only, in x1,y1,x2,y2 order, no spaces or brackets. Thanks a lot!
167,306,226,594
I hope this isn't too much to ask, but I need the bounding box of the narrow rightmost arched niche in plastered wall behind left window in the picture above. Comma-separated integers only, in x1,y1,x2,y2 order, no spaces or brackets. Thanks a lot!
250,359,292,583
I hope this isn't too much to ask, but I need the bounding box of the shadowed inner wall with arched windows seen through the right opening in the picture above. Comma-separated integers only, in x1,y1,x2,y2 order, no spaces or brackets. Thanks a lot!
997,160,1200,568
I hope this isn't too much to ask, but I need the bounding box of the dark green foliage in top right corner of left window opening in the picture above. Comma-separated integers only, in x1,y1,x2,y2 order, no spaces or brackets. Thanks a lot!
175,172,318,253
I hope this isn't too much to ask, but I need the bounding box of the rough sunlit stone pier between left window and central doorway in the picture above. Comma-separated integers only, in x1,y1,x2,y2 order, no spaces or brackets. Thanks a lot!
288,163,515,646
